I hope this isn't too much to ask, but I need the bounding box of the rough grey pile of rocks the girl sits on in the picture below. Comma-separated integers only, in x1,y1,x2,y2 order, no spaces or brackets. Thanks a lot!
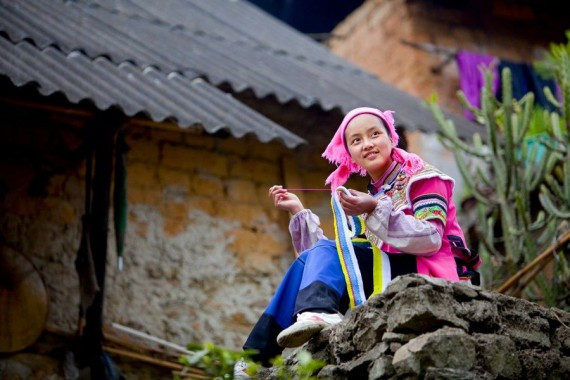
269,275,570,379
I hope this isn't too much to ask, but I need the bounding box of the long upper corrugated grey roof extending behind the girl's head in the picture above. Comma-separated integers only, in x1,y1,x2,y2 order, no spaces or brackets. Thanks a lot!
0,0,478,140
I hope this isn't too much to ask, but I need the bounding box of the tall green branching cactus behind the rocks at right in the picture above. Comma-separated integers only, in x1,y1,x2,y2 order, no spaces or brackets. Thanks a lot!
429,33,570,304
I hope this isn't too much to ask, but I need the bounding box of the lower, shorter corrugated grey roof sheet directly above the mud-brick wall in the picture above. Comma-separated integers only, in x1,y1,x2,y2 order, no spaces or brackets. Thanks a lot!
0,37,304,148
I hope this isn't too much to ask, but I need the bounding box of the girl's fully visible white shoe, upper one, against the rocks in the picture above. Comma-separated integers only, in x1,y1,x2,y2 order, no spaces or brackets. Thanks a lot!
277,311,342,347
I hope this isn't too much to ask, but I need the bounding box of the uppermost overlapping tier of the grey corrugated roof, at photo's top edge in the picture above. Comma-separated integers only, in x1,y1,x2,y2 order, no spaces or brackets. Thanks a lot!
72,0,356,75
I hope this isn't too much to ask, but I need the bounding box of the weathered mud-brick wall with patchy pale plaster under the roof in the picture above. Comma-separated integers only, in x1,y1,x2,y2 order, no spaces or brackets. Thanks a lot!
0,107,330,360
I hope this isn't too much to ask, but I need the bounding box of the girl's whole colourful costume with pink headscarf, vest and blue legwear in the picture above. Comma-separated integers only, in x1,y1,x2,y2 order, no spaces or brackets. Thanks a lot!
244,108,480,362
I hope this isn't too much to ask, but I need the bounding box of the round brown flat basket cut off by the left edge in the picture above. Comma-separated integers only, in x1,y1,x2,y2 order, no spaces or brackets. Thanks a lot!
0,245,48,352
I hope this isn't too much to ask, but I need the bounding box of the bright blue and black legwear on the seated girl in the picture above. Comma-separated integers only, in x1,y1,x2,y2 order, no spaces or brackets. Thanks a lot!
243,240,417,365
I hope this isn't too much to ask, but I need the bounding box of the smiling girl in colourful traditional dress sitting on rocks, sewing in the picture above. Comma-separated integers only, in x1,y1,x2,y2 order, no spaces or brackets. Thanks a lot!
240,107,480,363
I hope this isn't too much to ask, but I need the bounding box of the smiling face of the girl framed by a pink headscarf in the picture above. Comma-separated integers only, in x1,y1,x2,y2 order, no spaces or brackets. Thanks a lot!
344,114,392,181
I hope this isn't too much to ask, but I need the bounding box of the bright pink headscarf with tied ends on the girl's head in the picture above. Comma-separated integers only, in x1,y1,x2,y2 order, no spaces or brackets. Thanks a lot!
322,107,424,192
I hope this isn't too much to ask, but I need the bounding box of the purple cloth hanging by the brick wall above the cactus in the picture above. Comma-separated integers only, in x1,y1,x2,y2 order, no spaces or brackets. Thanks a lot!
457,50,499,120
